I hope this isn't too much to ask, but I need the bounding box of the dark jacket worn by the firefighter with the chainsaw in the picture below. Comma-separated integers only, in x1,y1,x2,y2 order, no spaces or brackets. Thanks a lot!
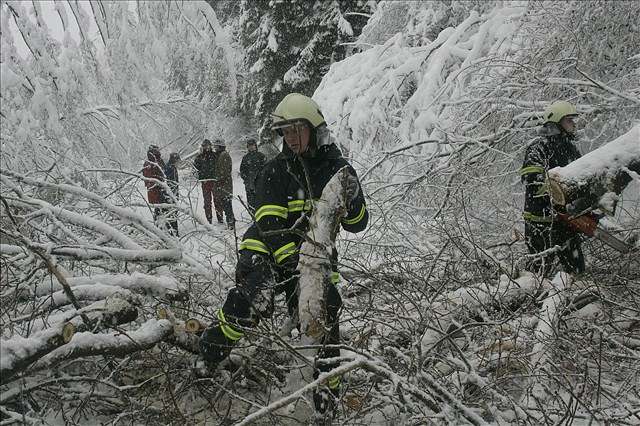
520,123,580,223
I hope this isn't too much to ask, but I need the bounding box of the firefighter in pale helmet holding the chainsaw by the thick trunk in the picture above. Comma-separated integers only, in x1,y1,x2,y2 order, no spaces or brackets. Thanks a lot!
520,101,585,275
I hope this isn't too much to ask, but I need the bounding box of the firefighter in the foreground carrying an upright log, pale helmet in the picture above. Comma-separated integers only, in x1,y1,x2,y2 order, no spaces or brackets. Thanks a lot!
200,93,369,412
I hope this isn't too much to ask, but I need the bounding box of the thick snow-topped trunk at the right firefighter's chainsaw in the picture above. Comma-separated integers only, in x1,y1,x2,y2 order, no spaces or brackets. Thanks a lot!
548,124,640,210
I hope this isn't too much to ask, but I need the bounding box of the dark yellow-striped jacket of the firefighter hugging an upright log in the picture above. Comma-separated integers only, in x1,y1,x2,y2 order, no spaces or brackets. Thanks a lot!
240,144,369,266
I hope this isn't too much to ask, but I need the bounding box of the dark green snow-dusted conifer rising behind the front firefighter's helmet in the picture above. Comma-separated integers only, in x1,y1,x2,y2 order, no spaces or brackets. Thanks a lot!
239,0,369,133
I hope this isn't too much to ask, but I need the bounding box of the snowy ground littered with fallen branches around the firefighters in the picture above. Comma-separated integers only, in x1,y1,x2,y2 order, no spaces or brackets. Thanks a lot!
0,153,640,425
